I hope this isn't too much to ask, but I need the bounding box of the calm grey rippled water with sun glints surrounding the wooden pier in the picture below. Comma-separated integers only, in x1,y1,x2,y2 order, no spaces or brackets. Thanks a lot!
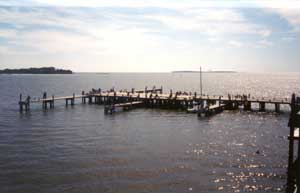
0,73,300,193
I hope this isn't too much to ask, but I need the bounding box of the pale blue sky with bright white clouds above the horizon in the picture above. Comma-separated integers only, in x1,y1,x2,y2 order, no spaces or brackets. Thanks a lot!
0,0,300,72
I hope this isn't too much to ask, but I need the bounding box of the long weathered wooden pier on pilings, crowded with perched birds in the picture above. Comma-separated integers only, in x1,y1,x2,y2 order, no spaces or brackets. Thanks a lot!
19,86,291,116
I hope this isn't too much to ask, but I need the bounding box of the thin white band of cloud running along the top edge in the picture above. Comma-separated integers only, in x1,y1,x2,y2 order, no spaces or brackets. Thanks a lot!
0,0,300,9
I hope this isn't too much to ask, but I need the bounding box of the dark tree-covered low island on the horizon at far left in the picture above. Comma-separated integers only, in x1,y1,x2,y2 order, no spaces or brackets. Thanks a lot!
0,67,73,74
